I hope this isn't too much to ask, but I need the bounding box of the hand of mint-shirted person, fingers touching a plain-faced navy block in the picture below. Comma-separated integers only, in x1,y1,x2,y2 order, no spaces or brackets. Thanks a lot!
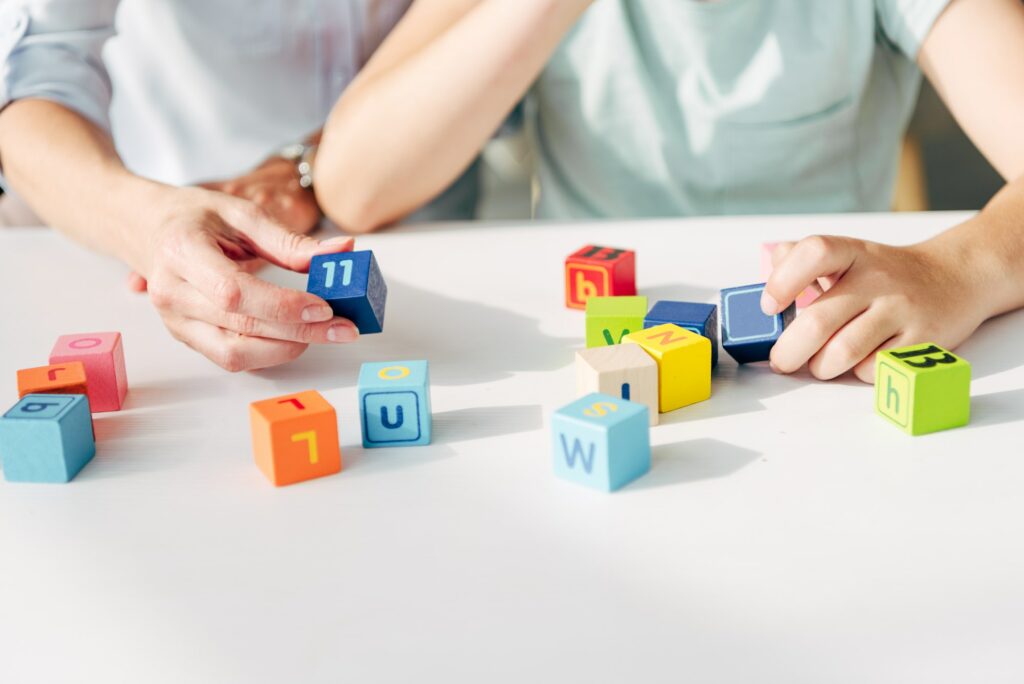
761,236,987,382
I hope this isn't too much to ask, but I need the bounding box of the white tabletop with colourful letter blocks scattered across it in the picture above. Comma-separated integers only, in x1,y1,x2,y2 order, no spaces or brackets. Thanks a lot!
0,214,1024,684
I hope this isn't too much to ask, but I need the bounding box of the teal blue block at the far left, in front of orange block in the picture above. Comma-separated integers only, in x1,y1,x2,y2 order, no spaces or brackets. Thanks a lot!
0,394,96,482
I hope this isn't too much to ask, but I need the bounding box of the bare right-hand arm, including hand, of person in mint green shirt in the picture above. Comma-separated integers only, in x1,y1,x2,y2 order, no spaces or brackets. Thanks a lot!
762,0,1024,382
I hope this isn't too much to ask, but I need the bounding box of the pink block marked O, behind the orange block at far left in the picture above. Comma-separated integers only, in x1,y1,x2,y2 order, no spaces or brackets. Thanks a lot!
50,333,128,413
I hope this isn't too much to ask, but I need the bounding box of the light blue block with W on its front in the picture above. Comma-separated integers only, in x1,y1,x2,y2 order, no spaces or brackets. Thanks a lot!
551,392,650,491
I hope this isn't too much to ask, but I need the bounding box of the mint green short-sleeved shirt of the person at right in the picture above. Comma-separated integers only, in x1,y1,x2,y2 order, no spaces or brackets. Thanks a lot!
526,0,948,218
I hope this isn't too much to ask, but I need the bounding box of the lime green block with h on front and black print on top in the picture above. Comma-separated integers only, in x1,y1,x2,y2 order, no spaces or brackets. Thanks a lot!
874,343,971,435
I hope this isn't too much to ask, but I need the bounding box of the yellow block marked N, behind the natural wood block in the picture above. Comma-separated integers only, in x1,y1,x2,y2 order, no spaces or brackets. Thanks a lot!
623,323,711,414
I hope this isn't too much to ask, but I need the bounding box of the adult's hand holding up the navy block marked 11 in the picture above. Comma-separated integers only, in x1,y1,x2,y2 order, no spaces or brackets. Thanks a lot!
132,188,357,372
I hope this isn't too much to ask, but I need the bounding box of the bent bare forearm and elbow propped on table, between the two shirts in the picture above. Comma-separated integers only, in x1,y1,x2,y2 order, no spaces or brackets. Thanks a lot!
314,0,590,232
